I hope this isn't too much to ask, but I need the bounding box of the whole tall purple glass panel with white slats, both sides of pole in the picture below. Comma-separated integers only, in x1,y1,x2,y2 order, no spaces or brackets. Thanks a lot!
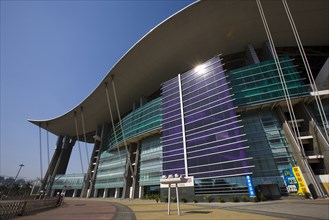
162,57,252,180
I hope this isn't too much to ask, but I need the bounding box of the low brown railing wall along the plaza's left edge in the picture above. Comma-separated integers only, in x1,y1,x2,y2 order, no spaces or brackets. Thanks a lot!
0,198,58,220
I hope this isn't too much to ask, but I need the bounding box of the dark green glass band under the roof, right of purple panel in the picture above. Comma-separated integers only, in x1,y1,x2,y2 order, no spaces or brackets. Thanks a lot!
226,57,309,107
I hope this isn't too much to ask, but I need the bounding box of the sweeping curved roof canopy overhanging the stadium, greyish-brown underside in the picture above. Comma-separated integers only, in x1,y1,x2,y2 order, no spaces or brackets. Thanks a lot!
29,0,329,140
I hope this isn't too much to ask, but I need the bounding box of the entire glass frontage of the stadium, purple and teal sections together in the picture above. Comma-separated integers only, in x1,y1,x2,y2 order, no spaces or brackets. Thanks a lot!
90,56,322,198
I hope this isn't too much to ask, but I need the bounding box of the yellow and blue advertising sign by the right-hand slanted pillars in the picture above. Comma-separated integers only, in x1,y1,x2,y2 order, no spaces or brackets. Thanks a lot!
282,166,309,194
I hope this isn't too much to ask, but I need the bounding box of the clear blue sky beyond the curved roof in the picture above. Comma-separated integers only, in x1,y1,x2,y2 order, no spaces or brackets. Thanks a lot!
0,0,193,179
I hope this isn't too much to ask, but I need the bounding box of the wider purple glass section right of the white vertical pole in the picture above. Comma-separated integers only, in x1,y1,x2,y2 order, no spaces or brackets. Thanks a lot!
182,55,246,178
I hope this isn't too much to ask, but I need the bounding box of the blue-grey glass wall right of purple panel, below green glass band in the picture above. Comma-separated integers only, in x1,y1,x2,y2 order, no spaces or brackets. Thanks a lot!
241,109,295,189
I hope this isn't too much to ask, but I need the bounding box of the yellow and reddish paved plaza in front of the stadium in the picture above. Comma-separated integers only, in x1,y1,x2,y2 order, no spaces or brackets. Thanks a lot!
11,198,329,220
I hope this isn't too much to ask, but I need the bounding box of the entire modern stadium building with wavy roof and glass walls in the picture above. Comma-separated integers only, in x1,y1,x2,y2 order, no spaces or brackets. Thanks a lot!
30,0,329,200
